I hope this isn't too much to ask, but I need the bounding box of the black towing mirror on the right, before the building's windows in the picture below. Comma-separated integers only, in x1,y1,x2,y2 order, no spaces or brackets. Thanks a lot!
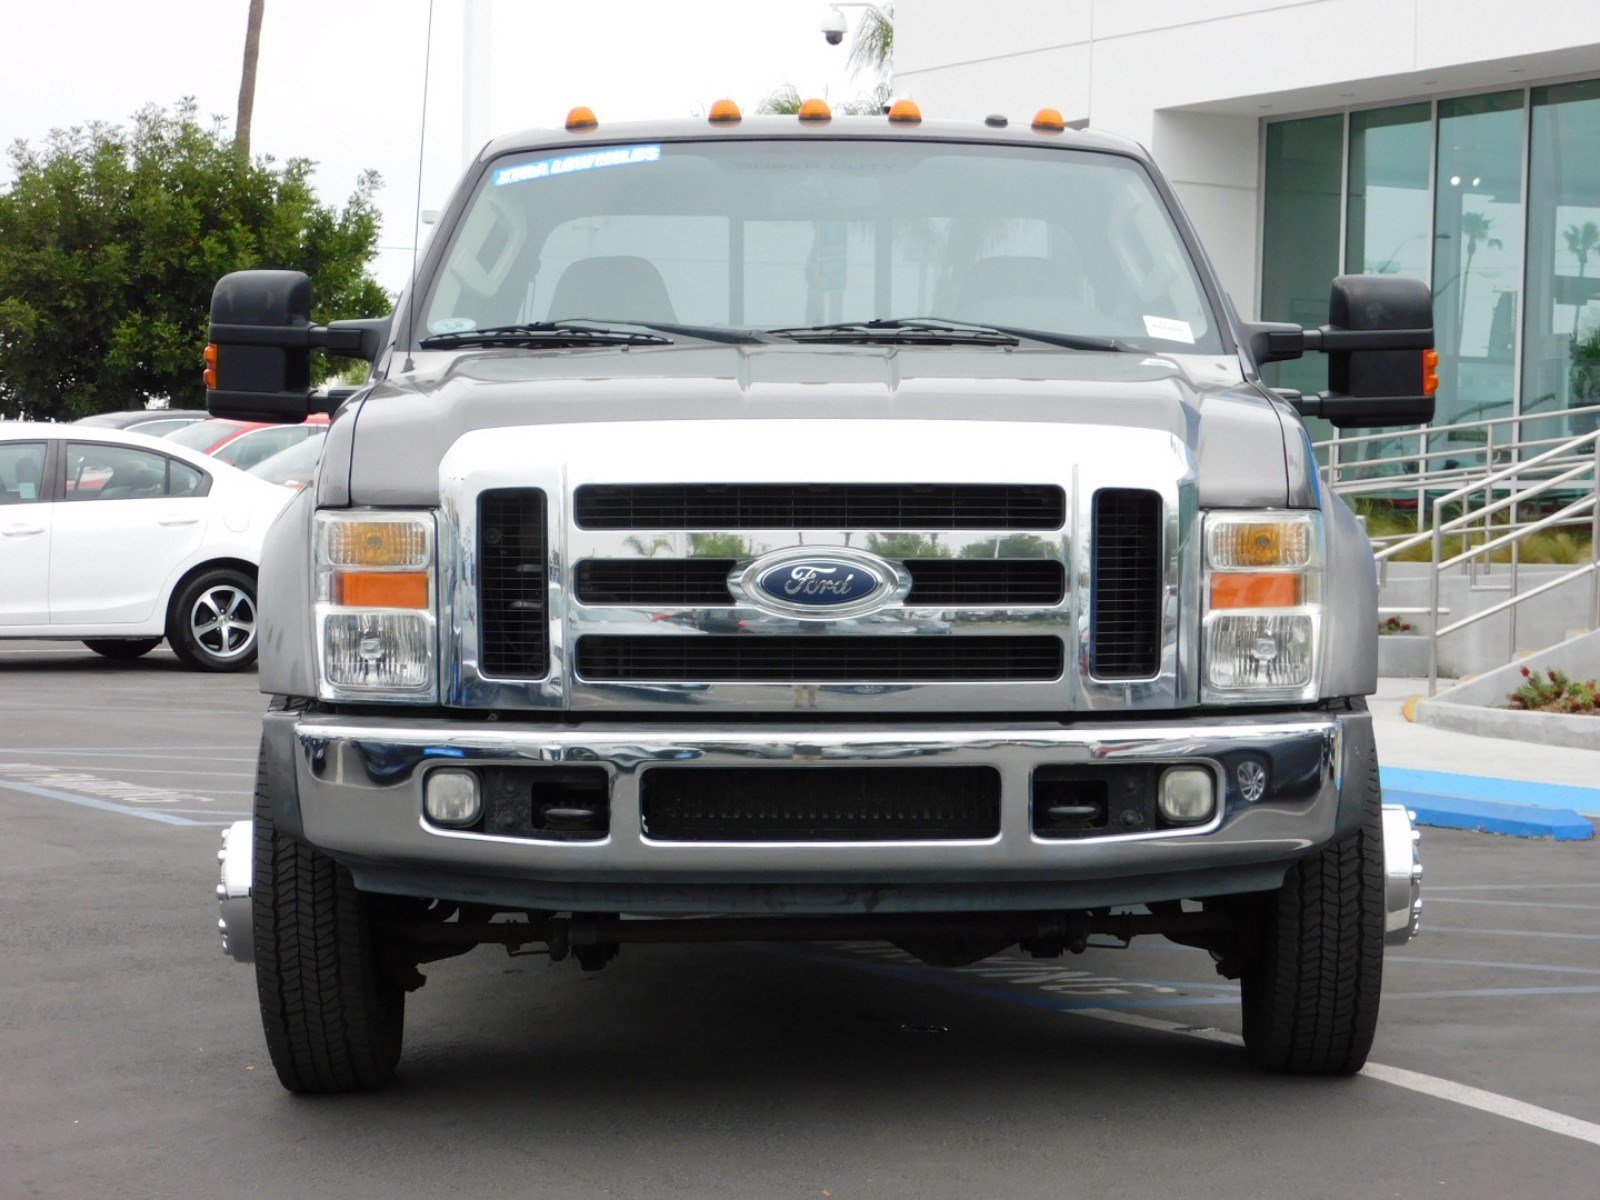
1245,275,1438,429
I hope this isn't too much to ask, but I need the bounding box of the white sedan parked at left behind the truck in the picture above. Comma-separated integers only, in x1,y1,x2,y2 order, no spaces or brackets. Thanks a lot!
0,422,291,670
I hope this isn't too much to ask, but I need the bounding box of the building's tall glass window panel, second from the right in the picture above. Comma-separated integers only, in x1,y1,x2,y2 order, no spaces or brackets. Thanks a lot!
1434,91,1523,444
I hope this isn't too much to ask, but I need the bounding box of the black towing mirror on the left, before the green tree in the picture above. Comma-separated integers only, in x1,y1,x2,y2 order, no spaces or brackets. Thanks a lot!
206,270,389,424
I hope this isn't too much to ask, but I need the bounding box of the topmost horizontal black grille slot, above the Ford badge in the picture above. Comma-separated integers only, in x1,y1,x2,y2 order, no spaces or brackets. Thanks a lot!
574,483,1067,530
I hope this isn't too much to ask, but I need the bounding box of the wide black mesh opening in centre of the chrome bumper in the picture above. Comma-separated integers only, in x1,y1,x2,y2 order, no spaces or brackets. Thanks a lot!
640,766,1000,842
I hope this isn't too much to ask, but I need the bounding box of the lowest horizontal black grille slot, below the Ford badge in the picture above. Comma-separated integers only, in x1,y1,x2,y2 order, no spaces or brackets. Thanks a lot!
578,634,1062,683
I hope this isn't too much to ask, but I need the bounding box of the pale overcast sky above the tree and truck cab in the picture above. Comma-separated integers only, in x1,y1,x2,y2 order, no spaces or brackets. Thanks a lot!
0,0,872,290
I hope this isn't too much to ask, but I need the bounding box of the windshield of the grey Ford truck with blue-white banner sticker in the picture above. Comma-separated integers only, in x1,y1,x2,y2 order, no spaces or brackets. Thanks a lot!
416,138,1221,352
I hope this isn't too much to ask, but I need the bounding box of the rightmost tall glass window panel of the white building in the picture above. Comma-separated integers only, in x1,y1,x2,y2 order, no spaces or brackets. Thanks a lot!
1522,80,1600,437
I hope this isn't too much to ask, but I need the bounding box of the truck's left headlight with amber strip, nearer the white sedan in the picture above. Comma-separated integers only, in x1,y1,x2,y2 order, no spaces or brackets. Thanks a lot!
314,510,438,704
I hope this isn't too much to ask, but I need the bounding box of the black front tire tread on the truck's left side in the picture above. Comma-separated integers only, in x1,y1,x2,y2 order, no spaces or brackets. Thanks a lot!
251,747,405,1094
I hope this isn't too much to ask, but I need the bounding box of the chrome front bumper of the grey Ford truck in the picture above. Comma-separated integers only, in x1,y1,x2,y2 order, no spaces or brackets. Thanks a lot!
267,712,1371,912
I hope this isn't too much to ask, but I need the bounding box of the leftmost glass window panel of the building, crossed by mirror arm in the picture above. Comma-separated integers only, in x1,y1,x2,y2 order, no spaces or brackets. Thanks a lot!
1261,112,1344,392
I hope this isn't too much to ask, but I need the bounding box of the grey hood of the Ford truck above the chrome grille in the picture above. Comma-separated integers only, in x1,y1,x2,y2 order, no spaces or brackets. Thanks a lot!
328,344,1317,518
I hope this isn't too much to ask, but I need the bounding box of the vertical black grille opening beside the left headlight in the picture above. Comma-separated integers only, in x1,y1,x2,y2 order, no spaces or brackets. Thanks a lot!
478,488,550,678
